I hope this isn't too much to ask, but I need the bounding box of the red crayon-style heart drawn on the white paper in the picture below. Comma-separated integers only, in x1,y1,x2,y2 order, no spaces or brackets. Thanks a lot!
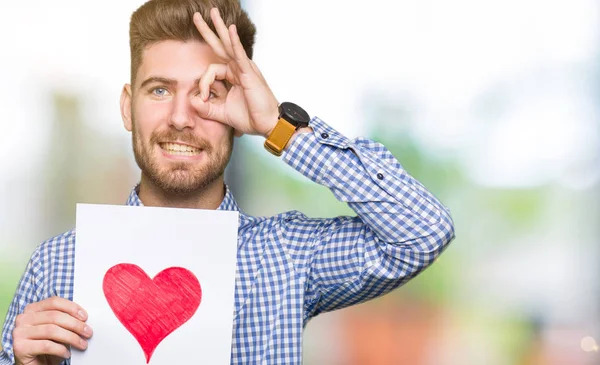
102,264,202,363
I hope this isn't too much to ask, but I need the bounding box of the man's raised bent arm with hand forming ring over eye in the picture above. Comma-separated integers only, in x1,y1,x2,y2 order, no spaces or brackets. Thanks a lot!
193,9,454,313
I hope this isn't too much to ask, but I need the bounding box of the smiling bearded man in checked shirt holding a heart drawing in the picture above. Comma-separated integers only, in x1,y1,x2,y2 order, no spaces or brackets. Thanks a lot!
0,0,454,365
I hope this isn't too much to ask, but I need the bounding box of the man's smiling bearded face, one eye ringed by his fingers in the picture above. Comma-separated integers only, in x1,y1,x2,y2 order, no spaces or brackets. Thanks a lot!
122,41,233,195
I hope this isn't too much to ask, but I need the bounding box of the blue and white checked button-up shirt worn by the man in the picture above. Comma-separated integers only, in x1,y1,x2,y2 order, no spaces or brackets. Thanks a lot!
0,118,454,365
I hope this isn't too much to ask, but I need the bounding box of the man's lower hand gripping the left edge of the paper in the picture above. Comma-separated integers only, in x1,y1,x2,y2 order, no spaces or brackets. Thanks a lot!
13,297,92,365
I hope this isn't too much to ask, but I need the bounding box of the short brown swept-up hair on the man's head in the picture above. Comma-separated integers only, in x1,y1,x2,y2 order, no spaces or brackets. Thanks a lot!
129,0,256,85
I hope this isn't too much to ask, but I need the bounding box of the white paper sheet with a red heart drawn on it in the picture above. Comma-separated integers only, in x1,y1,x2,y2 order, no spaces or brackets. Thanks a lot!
71,204,239,365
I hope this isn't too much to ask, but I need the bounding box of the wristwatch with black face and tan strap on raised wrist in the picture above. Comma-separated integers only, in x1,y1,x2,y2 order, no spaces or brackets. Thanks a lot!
265,101,310,156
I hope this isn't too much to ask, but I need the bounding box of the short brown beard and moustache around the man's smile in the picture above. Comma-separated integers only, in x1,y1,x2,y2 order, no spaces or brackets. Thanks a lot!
132,116,233,196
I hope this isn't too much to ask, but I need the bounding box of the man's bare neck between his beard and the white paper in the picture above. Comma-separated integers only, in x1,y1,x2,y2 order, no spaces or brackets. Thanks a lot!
138,174,225,210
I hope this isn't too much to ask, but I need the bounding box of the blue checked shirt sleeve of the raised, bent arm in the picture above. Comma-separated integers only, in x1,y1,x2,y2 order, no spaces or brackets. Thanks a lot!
282,117,454,319
